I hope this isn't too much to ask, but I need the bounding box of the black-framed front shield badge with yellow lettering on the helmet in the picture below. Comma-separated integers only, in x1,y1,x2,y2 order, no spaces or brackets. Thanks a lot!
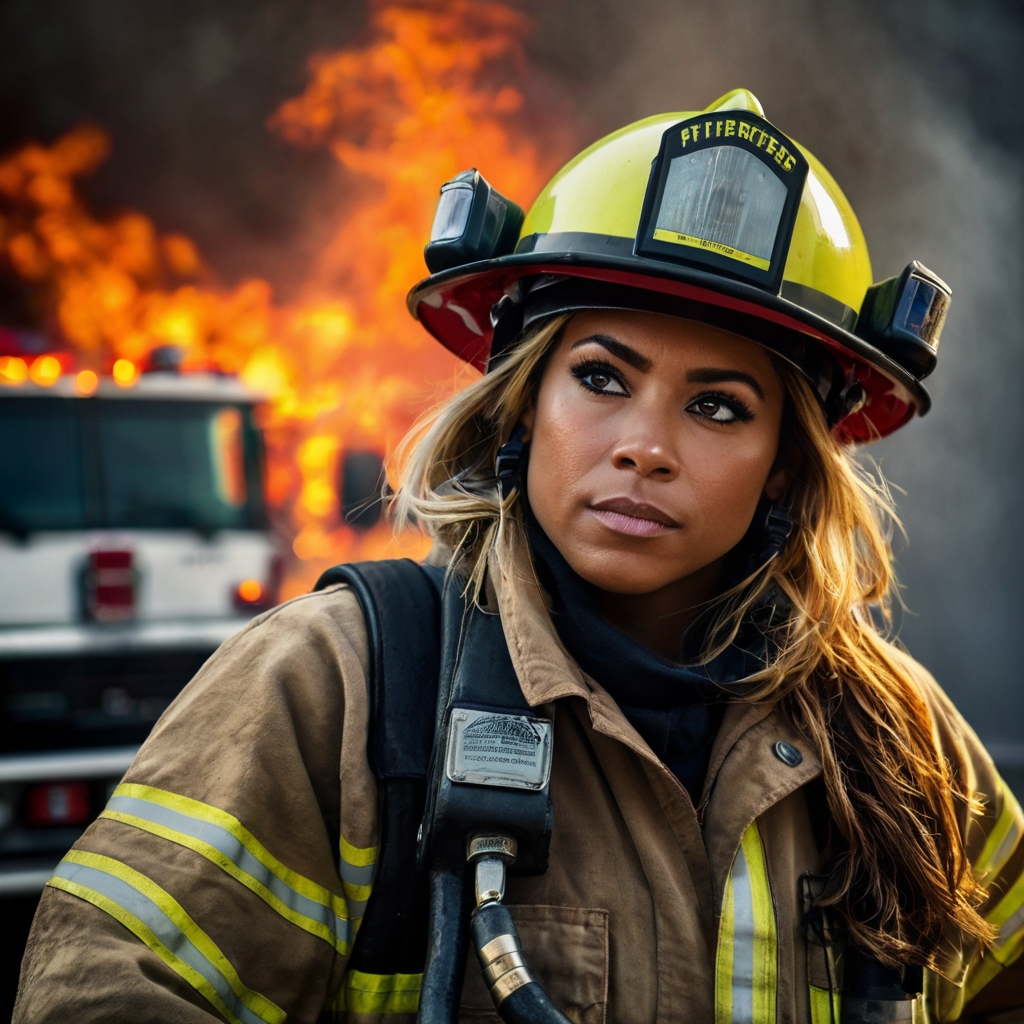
634,110,807,295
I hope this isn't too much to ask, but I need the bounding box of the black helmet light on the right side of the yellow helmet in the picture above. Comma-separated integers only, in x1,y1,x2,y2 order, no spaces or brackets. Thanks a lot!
855,260,952,380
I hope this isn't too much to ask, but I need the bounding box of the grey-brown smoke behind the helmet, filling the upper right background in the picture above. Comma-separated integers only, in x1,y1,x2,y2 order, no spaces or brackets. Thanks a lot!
540,0,1024,768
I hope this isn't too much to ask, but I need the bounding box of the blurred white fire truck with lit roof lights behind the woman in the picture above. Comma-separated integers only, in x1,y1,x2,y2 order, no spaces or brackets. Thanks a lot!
0,360,281,896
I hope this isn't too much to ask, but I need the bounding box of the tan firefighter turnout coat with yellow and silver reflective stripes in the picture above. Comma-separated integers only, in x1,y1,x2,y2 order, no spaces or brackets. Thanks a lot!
14,537,1024,1024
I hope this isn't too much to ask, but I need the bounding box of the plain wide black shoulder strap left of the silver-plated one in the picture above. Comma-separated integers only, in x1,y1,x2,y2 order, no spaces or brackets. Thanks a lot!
314,558,444,975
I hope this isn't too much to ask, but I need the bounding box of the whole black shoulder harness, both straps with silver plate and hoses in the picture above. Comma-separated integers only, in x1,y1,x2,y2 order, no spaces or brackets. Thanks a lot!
315,559,568,1024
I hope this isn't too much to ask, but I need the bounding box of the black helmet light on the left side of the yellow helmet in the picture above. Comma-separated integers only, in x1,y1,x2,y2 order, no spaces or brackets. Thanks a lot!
423,167,525,273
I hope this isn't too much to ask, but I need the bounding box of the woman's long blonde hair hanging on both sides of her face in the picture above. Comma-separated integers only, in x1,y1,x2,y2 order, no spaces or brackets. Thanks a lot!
393,316,993,967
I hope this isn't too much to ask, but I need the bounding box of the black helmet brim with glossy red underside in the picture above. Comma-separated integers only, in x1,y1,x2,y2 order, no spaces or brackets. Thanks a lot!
408,252,931,441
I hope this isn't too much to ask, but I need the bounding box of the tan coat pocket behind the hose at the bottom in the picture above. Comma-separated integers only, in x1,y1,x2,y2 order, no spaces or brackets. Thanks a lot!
459,904,608,1024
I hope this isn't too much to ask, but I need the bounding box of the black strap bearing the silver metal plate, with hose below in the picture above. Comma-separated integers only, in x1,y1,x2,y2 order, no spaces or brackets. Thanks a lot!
417,580,568,1024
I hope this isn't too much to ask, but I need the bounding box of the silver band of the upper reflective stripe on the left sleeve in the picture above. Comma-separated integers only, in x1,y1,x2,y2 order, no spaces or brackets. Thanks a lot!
106,796,351,943
